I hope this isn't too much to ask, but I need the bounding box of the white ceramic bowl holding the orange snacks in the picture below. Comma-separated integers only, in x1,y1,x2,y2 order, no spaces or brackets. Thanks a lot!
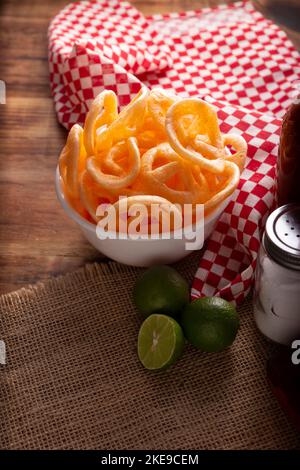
55,168,232,267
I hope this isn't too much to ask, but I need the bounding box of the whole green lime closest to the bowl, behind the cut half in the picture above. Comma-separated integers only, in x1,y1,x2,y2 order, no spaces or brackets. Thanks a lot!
133,266,189,318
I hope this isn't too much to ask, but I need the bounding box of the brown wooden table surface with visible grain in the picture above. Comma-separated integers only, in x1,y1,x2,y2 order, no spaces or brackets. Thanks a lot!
0,0,298,293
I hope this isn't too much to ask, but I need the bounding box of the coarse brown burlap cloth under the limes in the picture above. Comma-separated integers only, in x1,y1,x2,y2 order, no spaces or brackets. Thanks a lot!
0,255,299,450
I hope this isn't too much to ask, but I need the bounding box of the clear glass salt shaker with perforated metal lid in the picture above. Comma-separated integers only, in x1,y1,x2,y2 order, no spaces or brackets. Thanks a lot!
254,204,300,346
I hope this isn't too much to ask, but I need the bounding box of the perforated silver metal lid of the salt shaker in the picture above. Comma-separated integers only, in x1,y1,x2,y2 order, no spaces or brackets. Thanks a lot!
264,204,300,270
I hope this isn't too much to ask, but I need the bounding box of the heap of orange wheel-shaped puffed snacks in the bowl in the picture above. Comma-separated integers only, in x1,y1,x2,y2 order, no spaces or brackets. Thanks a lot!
59,87,247,233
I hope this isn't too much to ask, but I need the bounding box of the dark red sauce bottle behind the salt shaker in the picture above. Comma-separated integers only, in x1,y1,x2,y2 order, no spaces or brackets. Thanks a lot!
277,97,300,206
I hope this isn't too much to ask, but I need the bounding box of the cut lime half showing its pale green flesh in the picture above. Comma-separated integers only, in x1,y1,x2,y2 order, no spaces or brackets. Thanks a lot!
138,314,184,370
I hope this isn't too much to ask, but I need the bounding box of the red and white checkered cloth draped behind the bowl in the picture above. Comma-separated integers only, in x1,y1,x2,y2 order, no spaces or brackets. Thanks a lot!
49,0,300,303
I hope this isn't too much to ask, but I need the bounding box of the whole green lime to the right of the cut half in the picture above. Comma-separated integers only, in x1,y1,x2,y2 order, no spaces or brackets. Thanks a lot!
181,297,240,352
